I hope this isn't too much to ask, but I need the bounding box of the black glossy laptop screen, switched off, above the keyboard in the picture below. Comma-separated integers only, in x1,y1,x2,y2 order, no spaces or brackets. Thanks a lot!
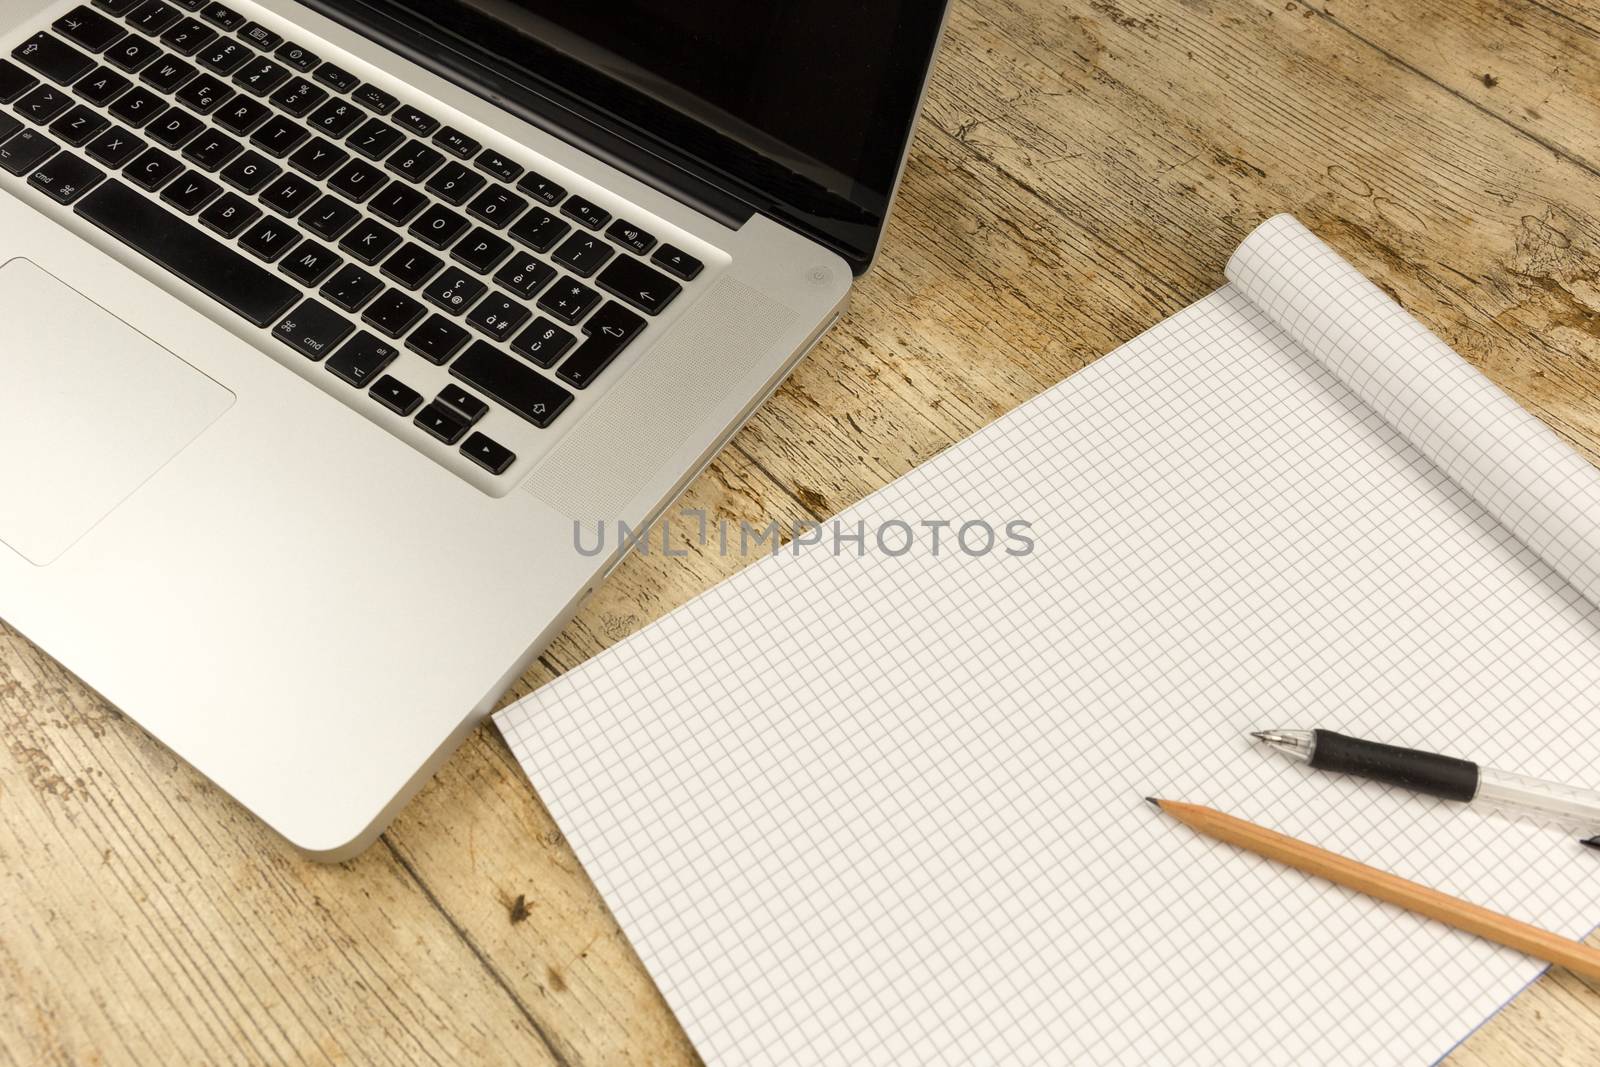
318,0,946,270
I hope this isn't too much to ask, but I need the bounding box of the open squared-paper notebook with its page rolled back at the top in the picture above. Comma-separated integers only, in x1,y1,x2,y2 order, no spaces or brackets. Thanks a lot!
498,216,1600,1067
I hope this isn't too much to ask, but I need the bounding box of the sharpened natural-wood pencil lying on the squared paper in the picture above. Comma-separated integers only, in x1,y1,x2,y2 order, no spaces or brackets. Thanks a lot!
1146,797,1600,979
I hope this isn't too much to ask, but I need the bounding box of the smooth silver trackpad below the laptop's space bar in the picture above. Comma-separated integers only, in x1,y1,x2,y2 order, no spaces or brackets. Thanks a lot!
0,259,234,566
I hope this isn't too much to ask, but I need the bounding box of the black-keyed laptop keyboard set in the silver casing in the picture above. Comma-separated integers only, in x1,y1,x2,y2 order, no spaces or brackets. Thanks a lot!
0,0,702,477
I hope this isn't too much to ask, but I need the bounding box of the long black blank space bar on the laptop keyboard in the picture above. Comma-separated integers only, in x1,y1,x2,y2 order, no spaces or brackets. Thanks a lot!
77,181,301,326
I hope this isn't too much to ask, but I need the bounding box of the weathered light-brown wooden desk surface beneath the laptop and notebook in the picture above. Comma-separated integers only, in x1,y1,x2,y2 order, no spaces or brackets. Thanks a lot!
0,0,1600,1065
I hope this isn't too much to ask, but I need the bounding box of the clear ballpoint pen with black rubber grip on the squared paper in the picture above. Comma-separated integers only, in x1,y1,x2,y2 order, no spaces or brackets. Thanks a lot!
1251,729,1600,831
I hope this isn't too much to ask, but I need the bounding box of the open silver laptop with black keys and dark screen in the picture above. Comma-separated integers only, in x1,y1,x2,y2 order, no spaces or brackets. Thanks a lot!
0,0,944,861
